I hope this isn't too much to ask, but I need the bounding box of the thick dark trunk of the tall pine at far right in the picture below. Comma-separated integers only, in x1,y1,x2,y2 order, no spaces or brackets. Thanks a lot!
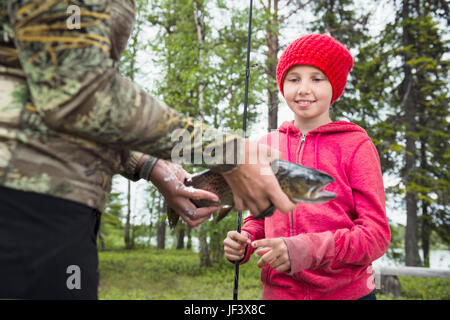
402,0,422,266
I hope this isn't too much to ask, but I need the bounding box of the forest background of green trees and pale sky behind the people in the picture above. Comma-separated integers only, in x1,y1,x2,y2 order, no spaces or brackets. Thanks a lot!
99,0,450,298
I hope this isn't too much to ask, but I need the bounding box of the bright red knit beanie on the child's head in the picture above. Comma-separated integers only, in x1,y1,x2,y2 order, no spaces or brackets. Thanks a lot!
277,34,353,104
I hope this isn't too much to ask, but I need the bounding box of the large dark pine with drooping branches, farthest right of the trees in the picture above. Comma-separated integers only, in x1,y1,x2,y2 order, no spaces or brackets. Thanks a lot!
385,0,449,266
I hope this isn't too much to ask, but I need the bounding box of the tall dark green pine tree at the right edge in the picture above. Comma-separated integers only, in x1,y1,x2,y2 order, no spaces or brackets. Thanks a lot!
368,0,449,266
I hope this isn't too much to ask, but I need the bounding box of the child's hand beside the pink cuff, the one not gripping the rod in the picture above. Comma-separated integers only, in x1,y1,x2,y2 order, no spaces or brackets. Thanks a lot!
252,238,291,272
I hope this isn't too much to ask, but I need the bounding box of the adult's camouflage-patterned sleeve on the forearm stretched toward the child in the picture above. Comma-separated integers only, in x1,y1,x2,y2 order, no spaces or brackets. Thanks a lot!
8,0,242,172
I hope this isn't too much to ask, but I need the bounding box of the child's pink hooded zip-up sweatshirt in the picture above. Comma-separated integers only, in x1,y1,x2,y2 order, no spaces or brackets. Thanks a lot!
242,121,390,300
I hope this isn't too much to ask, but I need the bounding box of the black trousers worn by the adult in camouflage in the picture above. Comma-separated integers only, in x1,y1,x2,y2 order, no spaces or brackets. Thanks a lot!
0,187,100,300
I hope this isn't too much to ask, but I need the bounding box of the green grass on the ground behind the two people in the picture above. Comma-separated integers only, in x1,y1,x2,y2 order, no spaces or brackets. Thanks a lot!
99,248,450,300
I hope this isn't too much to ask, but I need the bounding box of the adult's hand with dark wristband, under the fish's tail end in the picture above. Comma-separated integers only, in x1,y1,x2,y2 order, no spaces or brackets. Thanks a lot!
149,160,219,227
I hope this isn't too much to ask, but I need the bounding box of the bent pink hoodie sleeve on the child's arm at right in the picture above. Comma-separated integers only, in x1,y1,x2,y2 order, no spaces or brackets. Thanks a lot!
283,140,390,274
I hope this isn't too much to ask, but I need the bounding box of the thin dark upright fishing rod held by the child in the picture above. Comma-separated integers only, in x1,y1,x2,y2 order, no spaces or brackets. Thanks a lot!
233,0,253,300
